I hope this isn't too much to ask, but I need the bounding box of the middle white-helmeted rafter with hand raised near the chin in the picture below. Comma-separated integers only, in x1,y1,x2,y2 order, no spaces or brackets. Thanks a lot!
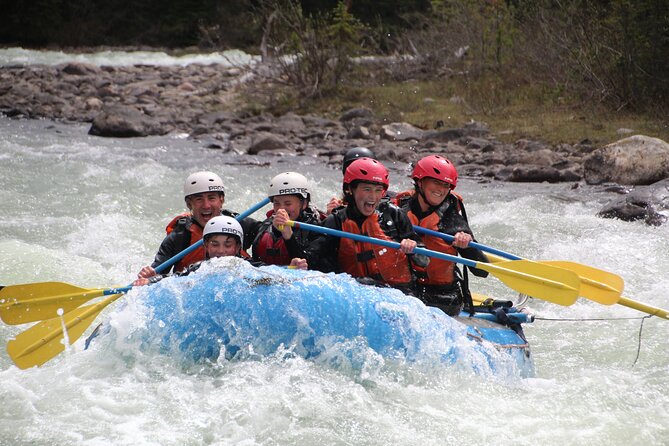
252,172,325,265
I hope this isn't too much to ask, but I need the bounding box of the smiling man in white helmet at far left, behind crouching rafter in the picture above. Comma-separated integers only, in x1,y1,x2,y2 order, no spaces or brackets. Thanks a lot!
137,172,260,278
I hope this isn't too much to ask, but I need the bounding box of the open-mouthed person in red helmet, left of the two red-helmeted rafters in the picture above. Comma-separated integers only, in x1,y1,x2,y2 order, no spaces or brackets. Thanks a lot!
306,158,429,292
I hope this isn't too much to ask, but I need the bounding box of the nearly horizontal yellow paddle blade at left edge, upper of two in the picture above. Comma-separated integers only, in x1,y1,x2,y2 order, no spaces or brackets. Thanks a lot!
0,282,104,325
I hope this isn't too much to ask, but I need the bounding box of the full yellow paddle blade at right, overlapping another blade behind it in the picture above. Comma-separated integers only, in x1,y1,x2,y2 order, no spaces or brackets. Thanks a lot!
476,260,580,306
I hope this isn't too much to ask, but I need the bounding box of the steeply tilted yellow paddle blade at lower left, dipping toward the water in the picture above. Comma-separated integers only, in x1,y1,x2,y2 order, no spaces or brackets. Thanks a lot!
7,294,123,369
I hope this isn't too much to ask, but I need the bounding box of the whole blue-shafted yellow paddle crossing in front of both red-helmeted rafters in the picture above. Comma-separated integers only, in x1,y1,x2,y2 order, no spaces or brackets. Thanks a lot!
287,221,579,305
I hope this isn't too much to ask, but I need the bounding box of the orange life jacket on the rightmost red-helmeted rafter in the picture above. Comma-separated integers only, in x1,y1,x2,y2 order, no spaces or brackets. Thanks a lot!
396,191,462,285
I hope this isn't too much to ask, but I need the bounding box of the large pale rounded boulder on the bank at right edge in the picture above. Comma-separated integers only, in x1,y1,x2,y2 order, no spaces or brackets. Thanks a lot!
583,135,669,185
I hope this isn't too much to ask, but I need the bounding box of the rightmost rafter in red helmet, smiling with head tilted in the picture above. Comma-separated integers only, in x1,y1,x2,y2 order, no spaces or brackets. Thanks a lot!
395,155,488,316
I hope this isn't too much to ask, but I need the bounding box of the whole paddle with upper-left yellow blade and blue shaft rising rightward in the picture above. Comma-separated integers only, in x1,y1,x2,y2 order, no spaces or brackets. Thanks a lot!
0,198,269,325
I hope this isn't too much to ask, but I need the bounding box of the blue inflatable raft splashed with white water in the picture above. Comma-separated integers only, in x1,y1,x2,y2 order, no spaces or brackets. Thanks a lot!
112,258,534,377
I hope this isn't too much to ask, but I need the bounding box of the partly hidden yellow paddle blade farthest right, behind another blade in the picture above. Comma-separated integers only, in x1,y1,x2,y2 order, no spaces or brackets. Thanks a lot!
540,260,625,305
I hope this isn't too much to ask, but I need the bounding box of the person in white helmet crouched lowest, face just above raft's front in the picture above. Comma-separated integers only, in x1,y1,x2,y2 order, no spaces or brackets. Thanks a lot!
132,215,307,286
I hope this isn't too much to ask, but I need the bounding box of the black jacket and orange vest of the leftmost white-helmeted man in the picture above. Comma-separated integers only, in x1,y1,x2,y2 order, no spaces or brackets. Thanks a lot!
151,209,261,272
